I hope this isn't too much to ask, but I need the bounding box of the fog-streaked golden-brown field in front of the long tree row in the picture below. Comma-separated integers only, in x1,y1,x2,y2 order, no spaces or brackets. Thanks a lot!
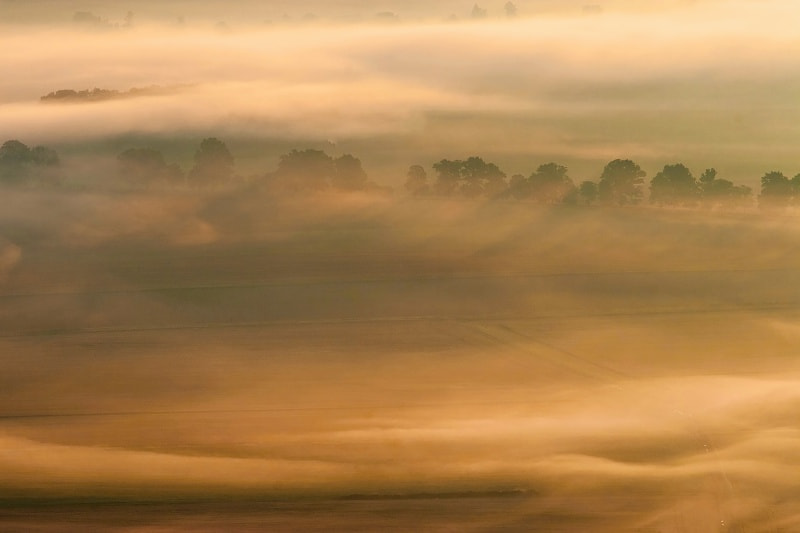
0,189,800,532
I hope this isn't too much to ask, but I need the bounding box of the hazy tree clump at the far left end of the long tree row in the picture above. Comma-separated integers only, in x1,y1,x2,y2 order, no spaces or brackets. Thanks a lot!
0,140,60,185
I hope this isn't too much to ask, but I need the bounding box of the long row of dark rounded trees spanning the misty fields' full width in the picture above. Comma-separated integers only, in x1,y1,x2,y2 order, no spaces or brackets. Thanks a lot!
0,137,800,209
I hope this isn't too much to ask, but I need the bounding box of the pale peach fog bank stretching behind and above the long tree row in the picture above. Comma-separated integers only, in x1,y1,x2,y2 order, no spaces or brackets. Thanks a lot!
0,0,798,184
